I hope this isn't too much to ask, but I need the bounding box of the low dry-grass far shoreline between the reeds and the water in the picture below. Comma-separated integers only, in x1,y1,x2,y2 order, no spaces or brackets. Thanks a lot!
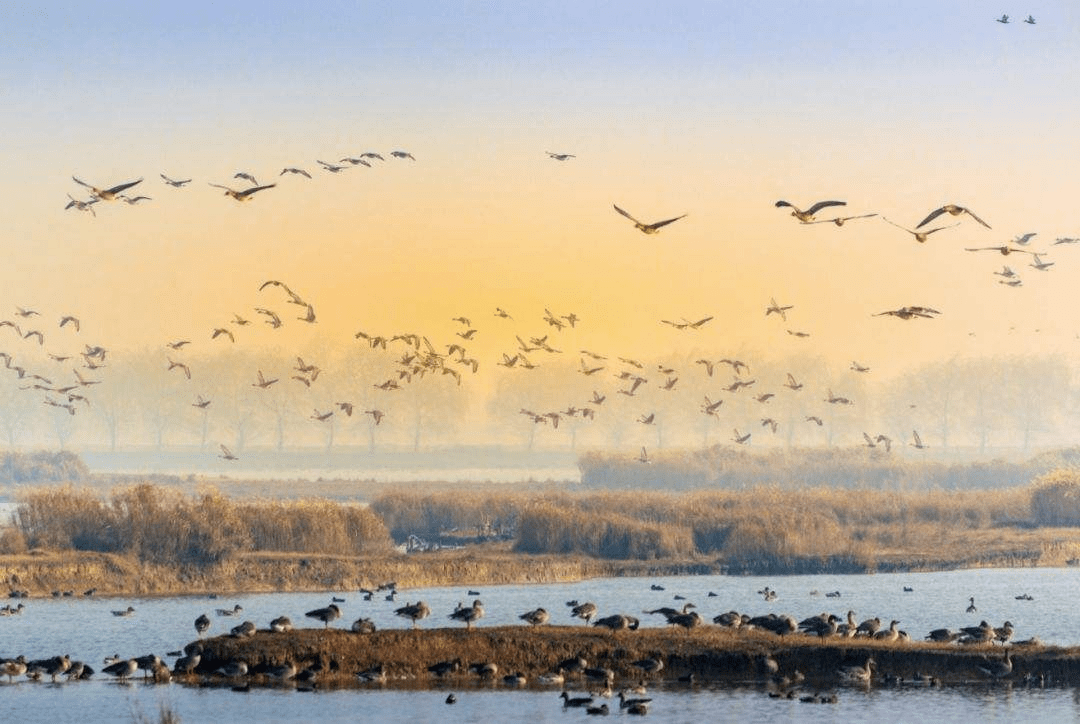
0,544,1070,598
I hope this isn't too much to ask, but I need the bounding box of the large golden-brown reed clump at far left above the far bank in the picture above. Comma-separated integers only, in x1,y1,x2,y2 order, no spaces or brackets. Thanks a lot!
14,484,390,565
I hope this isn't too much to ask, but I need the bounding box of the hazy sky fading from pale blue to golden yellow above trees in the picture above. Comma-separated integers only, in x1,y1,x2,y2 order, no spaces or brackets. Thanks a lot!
0,0,1080,438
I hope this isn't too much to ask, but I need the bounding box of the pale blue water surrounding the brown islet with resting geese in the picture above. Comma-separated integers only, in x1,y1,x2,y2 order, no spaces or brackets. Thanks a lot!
6,568,1080,724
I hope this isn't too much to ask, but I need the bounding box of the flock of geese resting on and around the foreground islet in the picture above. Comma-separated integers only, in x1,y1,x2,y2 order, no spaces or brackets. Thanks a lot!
0,581,1045,714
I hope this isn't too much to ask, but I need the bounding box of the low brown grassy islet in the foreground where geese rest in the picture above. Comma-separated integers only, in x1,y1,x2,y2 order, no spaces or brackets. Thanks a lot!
190,626,1080,688
